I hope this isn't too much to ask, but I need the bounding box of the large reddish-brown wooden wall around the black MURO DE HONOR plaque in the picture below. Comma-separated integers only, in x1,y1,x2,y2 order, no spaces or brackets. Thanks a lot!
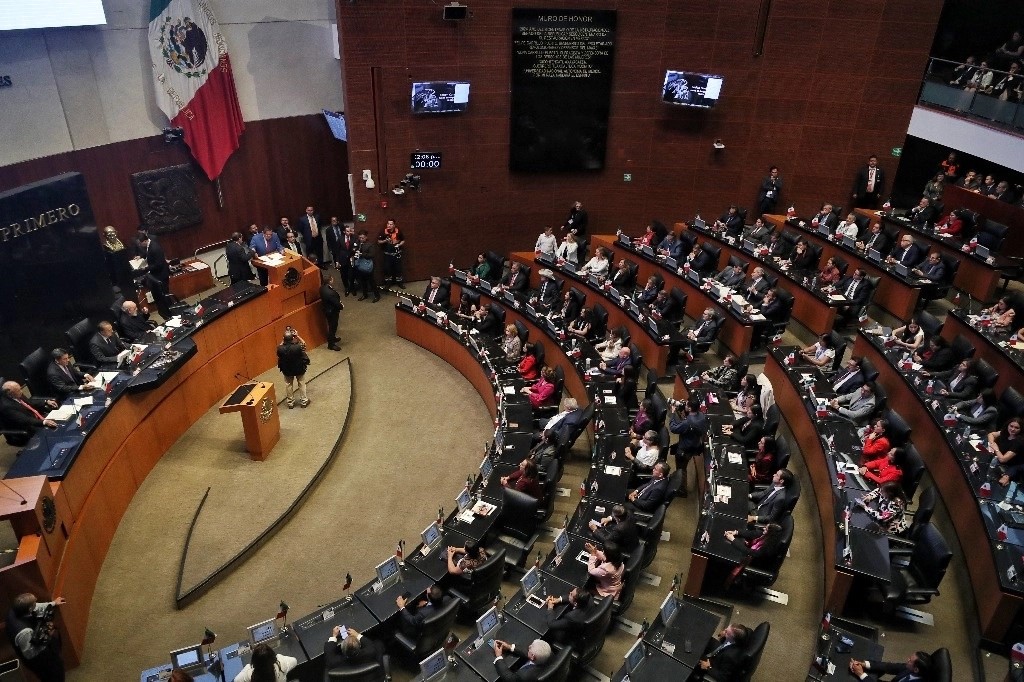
337,0,942,279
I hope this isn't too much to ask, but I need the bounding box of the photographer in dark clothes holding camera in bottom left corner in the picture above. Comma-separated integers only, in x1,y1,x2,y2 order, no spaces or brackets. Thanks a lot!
7,592,67,682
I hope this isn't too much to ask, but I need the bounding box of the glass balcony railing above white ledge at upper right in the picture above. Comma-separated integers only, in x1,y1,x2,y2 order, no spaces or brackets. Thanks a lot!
918,58,1024,130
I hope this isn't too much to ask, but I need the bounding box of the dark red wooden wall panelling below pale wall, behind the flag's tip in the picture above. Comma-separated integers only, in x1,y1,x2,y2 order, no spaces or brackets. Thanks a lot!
0,115,351,259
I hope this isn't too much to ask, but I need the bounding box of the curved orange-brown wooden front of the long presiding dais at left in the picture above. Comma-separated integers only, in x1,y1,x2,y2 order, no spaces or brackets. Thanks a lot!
0,254,326,666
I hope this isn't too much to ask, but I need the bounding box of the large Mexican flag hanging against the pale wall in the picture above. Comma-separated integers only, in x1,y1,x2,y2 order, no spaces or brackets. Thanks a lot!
150,0,245,180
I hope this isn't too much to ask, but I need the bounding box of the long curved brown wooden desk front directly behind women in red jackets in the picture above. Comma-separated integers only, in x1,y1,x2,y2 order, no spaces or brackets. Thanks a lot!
851,331,1024,645
